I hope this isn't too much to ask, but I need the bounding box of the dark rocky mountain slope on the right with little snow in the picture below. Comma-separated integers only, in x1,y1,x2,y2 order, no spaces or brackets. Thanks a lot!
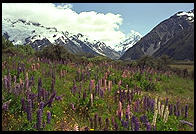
120,10,194,60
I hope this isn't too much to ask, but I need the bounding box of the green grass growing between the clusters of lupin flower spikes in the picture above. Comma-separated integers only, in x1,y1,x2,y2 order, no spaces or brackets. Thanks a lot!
2,54,194,131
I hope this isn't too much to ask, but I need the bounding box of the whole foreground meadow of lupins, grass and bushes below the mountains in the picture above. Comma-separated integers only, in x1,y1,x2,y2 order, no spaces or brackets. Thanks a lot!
2,37,194,131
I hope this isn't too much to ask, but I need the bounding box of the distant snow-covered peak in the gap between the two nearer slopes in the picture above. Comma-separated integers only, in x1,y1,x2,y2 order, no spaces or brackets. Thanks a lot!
115,30,142,55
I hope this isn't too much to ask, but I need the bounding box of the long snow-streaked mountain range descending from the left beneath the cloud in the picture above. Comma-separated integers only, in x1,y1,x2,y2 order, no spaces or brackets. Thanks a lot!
2,18,120,59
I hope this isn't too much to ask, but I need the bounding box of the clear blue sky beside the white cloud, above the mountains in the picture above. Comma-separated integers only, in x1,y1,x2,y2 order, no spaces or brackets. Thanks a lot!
57,3,194,36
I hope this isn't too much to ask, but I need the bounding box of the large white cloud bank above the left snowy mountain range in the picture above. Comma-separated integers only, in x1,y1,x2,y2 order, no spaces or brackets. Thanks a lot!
2,3,125,47
